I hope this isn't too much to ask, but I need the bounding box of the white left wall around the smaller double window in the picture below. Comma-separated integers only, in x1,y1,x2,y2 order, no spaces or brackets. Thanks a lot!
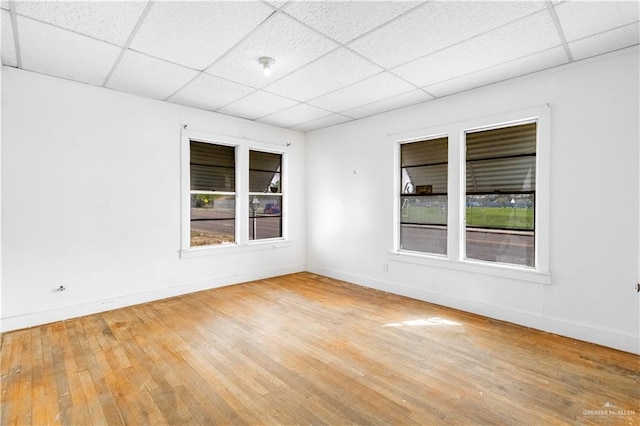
1,68,306,331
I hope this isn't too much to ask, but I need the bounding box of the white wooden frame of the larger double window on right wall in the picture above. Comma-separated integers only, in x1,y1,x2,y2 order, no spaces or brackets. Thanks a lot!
388,104,551,284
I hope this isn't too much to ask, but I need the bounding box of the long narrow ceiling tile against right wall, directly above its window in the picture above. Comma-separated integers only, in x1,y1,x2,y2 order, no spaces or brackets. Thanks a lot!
425,47,568,97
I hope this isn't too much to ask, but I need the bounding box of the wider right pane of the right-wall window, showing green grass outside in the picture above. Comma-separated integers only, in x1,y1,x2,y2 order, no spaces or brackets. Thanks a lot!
465,122,537,266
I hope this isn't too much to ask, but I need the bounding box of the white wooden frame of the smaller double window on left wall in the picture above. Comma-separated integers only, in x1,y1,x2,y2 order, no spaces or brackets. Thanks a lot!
179,126,291,259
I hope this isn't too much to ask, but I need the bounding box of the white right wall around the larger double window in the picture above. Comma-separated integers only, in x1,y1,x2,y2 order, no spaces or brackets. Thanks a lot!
307,47,640,353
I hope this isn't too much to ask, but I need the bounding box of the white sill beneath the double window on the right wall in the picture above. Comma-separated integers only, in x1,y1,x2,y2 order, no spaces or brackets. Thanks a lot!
387,252,551,285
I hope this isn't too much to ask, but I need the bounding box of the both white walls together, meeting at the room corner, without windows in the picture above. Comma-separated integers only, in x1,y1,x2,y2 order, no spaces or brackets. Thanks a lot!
0,47,640,353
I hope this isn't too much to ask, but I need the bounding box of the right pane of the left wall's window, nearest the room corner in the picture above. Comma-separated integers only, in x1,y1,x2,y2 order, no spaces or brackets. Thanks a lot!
249,151,282,240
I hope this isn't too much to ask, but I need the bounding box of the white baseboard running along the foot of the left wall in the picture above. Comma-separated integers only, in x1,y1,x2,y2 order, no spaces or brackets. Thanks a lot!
0,264,305,333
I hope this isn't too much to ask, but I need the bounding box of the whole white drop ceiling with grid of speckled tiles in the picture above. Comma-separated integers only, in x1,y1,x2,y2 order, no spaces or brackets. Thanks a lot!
0,0,640,131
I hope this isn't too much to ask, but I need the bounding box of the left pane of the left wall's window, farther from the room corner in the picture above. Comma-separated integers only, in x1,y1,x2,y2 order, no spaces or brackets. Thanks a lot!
189,141,236,247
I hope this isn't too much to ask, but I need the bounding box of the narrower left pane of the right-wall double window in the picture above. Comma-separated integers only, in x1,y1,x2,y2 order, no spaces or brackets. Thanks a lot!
400,137,448,254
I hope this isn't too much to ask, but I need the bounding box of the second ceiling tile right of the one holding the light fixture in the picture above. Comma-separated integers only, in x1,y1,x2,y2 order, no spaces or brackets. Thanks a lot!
309,72,415,112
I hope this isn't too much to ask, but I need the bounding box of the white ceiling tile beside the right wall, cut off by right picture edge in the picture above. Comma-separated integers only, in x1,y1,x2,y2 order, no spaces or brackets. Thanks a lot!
569,22,640,60
